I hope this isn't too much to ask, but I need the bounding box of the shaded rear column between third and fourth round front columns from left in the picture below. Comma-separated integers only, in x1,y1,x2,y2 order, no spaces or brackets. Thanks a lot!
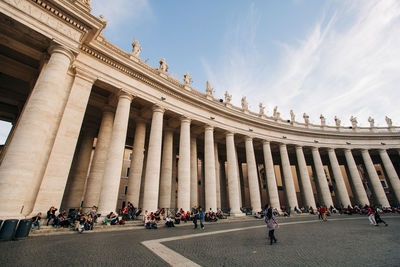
159,128,174,208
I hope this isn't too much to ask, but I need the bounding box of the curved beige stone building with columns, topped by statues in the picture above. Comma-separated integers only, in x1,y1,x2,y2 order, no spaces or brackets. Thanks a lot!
0,0,400,219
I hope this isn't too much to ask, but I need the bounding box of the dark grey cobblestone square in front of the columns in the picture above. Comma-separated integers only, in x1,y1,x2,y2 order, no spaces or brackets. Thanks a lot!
0,215,400,266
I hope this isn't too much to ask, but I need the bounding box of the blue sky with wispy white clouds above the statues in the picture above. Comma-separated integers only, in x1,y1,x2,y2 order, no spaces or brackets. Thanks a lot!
0,0,400,144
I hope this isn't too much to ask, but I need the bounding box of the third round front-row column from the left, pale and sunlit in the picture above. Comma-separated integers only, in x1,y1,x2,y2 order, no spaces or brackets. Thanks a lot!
143,106,164,212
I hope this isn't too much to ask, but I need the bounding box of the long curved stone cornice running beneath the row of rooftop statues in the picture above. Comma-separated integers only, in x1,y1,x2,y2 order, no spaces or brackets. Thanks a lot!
81,39,400,140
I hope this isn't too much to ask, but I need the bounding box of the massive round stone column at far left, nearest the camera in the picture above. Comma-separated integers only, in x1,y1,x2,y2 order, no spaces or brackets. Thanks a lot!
0,45,73,219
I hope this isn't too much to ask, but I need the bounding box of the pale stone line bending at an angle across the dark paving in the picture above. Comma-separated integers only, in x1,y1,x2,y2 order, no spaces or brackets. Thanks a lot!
142,216,382,266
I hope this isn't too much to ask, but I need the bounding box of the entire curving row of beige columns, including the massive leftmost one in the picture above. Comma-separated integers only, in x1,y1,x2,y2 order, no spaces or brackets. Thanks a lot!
0,45,400,221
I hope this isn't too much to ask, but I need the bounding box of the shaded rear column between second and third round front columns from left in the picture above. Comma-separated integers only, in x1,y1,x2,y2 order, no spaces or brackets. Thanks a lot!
126,119,146,208
